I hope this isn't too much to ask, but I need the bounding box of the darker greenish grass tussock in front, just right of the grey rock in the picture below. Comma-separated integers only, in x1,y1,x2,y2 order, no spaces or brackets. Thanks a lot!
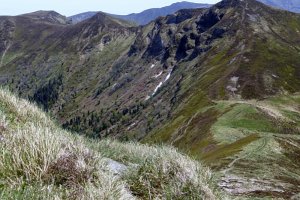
126,154,215,199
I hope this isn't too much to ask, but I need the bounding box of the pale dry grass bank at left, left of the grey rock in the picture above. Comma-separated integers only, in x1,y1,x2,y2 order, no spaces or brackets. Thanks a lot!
0,90,132,199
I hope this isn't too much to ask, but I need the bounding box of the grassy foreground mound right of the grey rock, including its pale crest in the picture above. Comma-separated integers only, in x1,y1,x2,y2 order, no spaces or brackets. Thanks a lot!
94,140,220,199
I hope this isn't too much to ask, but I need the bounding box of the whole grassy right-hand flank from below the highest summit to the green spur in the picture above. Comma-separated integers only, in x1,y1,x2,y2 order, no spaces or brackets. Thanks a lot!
144,4,300,198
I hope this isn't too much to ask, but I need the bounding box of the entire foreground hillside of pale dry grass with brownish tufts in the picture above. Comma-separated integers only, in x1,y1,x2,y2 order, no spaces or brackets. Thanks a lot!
0,90,224,199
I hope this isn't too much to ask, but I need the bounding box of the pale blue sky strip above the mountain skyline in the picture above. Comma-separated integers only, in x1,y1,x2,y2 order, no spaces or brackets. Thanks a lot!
0,0,219,16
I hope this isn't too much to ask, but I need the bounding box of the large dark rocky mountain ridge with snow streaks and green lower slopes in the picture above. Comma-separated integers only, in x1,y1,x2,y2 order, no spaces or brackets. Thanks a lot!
0,0,300,199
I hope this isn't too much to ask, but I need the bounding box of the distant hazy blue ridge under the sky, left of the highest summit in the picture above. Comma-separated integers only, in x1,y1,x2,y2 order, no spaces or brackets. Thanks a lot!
69,1,210,25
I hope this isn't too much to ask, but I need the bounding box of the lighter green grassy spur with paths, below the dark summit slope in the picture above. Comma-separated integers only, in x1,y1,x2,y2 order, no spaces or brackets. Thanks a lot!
146,94,300,198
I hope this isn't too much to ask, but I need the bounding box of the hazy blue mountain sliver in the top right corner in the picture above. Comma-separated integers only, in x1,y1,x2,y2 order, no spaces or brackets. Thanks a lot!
259,0,300,13
